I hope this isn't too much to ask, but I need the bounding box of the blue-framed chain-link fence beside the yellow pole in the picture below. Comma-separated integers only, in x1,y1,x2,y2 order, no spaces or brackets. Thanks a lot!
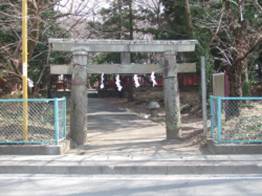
0,98,66,144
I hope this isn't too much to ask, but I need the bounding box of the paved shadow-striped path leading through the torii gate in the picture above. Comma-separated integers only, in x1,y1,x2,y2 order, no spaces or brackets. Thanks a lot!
70,95,200,158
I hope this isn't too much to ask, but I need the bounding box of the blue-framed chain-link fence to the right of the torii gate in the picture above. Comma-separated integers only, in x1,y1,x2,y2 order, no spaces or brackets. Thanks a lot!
210,96,262,143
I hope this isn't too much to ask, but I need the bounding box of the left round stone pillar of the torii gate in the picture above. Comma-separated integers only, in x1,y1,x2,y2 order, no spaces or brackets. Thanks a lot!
70,50,88,145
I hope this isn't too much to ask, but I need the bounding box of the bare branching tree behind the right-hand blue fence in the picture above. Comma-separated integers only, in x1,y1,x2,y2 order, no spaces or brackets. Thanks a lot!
195,0,262,96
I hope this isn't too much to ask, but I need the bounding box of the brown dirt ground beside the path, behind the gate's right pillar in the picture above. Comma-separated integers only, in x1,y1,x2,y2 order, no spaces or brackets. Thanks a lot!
106,88,203,140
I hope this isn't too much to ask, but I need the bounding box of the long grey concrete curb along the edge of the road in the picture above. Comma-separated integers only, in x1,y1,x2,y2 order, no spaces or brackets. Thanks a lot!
0,160,262,175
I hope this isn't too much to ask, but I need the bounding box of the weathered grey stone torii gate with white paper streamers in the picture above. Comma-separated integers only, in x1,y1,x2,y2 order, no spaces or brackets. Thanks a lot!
49,39,197,145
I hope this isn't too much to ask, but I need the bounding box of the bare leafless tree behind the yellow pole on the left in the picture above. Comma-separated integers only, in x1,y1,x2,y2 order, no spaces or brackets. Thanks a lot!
0,0,97,93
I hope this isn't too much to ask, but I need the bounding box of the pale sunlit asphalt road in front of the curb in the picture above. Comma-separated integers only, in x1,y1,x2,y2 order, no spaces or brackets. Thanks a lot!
0,175,262,196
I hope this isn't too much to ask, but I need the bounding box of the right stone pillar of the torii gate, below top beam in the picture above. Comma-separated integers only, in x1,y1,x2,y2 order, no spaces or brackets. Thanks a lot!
164,52,181,139
